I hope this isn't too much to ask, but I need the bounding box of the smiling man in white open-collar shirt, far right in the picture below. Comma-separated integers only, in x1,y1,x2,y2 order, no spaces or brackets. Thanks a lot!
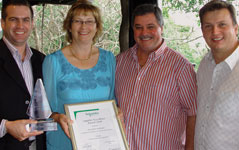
195,0,239,150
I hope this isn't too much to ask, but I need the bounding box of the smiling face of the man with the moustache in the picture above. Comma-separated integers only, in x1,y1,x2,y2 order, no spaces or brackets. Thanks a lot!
133,13,163,53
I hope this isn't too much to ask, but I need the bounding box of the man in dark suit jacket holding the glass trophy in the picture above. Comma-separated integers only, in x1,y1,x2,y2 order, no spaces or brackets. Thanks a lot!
0,0,46,150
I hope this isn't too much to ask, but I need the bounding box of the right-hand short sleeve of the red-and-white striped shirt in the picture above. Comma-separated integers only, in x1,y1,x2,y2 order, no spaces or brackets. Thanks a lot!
178,63,197,116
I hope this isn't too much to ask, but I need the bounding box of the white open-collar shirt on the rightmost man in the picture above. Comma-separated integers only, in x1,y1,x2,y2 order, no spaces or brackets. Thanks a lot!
195,48,239,150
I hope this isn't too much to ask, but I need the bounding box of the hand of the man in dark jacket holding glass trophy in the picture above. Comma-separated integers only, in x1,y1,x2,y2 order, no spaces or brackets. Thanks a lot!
5,120,43,141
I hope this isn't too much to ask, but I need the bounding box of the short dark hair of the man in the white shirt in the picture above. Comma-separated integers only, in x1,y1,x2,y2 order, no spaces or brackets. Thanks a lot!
199,0,237,25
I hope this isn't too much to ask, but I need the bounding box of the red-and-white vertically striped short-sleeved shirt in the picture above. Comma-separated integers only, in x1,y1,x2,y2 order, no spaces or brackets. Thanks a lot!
115,42,197,150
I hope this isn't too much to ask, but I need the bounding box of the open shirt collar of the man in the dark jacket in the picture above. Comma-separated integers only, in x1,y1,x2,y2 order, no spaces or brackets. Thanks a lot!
3,36,32,60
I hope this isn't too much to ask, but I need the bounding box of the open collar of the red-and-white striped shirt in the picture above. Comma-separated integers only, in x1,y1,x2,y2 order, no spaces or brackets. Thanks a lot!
131,39,167,60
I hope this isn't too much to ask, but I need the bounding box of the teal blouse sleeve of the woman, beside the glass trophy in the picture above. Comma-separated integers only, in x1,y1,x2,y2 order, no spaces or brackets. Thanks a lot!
42,54,58,112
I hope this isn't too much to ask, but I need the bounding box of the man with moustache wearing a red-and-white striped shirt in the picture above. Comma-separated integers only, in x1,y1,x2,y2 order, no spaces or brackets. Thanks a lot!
115,4,197,150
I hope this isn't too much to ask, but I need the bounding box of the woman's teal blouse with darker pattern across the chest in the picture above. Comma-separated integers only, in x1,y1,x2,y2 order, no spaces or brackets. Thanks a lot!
43,48,116,150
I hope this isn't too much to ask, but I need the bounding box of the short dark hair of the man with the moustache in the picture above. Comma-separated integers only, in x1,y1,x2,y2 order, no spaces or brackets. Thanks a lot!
131,4,164,27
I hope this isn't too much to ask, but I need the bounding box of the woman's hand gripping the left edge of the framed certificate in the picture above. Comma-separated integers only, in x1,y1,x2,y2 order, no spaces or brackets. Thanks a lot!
51,113,73,138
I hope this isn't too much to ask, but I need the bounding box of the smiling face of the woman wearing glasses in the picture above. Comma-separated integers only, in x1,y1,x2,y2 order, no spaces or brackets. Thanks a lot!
71,11,97,42
